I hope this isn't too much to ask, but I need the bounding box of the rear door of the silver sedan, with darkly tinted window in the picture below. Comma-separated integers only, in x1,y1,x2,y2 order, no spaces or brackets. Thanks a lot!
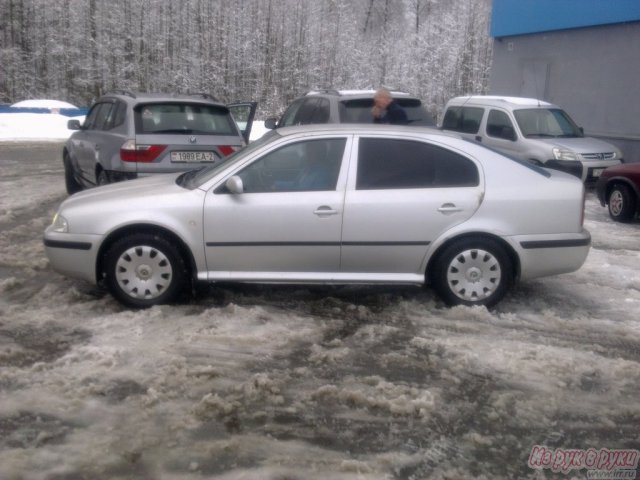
341,137,483,282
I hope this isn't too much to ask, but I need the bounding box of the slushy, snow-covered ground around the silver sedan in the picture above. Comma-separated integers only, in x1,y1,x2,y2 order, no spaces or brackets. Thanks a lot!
0,142,640,480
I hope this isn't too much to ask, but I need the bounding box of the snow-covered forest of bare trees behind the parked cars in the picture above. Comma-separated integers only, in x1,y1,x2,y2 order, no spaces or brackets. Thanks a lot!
0,0,492,115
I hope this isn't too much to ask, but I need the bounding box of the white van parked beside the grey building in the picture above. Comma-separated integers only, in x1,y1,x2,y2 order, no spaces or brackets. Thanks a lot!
442,95,623,184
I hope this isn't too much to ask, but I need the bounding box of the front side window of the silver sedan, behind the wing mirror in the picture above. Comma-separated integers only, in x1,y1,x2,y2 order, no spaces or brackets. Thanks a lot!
237,138,346,193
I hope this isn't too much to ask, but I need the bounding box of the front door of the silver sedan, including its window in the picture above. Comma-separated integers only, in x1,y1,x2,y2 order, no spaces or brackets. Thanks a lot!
204,137,348,281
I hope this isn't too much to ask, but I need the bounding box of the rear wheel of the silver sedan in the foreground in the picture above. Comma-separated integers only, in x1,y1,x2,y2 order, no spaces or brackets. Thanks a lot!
430,238,514,307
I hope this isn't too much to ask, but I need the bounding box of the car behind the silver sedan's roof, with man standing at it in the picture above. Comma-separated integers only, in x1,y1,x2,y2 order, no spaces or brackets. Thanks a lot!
264,90,435,129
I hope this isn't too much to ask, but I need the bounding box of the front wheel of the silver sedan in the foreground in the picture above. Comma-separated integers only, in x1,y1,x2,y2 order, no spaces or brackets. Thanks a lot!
105,233,188,308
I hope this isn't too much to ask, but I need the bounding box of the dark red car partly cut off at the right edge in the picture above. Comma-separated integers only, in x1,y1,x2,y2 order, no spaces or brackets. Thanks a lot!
596,163,640,222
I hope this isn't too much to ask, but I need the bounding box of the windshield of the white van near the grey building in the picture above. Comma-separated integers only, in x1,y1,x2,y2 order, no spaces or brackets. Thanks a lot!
513,108,583,138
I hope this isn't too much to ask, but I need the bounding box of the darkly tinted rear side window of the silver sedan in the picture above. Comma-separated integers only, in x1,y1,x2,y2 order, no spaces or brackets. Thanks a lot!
356,138,480,190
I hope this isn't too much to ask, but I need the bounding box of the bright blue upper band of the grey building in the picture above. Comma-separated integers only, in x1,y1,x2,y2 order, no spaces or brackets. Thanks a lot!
491,0,640,38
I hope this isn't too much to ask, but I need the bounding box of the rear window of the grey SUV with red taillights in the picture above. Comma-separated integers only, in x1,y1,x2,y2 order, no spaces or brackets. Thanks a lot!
135,103,239,135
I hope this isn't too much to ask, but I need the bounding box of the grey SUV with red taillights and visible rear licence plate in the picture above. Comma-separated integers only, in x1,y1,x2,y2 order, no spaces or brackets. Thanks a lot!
63,90,256,194
